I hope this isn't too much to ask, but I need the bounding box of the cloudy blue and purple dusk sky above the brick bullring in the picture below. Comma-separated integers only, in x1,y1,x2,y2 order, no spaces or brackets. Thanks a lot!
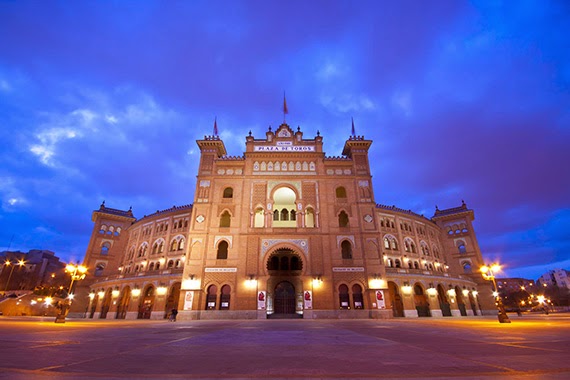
0,0,570,279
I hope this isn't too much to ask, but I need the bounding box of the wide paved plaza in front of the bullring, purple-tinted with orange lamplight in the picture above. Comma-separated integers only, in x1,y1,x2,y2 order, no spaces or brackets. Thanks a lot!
0,314,570,379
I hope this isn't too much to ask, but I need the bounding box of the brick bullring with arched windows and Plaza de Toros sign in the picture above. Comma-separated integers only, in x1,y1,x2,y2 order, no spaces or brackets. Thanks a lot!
75,123,495,319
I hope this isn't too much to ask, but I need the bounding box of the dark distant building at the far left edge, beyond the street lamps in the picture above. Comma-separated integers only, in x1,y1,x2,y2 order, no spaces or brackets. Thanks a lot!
0,249,69,292
